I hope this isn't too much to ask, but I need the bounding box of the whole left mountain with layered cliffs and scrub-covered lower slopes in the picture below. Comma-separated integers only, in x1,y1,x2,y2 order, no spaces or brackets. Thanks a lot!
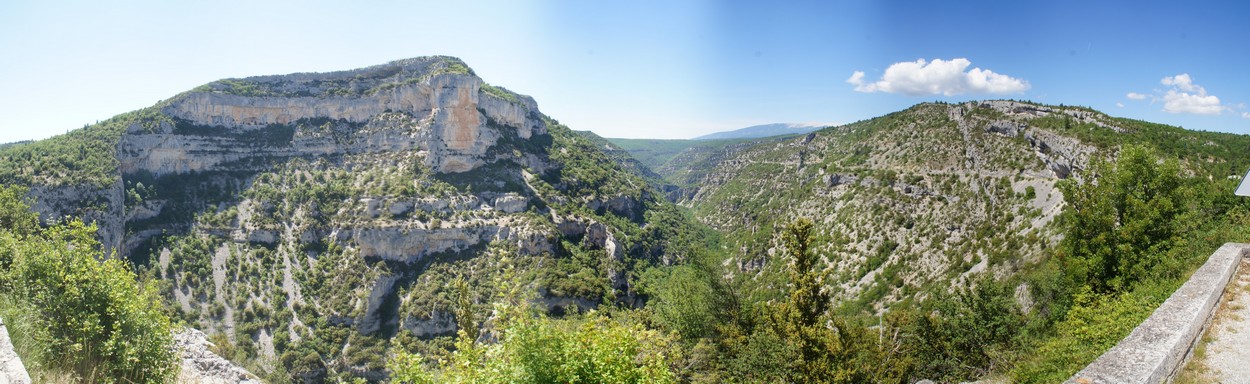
0,56,693,380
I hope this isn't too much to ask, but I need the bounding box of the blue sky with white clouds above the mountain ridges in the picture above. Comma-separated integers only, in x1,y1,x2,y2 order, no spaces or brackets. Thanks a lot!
0,0,1250,143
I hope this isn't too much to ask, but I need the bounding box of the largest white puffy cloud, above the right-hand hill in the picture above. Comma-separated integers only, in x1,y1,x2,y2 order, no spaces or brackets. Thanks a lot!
846,58,1030,96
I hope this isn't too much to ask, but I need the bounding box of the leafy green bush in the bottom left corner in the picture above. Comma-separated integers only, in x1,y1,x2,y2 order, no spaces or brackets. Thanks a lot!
0,188,176,383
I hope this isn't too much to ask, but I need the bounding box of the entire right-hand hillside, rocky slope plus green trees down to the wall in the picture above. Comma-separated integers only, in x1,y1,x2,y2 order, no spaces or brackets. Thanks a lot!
658,101,1250,383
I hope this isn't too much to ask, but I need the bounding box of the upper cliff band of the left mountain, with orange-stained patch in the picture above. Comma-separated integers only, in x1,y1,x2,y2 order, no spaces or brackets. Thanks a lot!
120,58,546,175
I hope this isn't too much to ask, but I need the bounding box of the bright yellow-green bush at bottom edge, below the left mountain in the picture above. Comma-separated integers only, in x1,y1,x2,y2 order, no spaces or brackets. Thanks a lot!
388,257,676,383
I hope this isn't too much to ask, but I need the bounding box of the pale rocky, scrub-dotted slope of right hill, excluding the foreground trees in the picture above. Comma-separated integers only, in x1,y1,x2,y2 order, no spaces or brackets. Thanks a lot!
675,100,1239,313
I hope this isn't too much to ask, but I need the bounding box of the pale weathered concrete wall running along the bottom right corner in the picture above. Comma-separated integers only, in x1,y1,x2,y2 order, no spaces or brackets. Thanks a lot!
1066,243,1250,384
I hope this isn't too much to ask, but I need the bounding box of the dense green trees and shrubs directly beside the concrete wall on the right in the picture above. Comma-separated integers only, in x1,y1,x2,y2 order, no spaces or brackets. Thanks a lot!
1010,146,1250,383
